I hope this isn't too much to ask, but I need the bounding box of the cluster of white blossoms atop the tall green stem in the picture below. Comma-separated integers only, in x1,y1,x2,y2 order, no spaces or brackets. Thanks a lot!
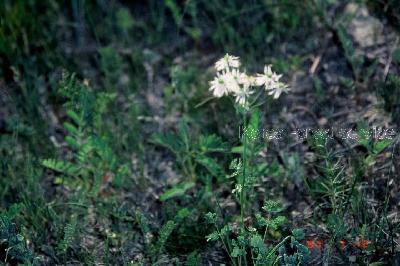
210,54,289,107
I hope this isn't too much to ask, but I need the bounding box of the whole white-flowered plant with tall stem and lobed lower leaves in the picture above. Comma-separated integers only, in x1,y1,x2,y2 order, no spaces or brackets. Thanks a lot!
206,54,298,265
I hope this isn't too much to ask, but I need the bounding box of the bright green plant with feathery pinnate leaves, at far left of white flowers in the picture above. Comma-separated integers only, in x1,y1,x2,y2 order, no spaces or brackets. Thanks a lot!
42,72,129,195
